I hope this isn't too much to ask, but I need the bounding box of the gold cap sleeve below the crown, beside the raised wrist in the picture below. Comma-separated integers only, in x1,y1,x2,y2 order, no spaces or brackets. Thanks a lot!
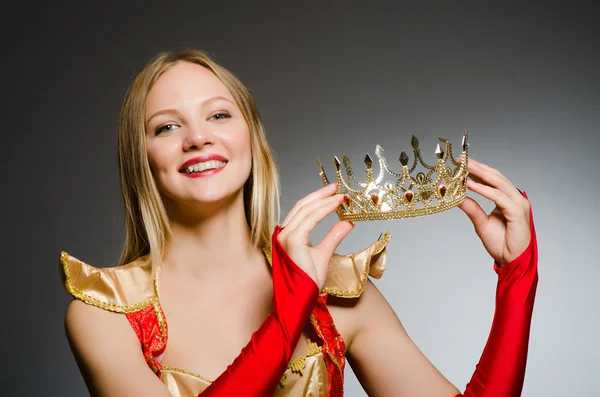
323,232,392,298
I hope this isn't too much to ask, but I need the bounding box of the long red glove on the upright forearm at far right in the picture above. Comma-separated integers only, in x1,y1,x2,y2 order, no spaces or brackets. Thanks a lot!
456,193,538,397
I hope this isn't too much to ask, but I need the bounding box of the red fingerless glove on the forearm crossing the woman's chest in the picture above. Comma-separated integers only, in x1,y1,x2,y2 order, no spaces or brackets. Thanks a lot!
201,226,319,397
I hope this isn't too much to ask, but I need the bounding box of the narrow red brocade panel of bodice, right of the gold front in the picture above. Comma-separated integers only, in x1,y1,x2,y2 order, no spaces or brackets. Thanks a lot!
311,293,346,397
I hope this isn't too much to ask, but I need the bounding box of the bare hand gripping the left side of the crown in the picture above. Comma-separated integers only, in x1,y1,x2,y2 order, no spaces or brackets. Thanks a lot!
278,183,354,291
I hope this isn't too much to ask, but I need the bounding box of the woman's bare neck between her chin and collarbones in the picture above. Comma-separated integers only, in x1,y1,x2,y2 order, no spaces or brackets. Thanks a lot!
163,192,262,279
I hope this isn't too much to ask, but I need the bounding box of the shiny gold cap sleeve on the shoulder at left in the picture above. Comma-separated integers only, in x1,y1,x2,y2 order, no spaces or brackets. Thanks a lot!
59,251,158,313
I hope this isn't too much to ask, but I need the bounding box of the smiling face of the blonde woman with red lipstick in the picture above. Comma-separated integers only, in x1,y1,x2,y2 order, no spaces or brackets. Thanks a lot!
145,62,252,213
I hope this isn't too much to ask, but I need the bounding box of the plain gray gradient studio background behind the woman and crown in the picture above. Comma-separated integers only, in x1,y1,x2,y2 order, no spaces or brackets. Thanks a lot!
0,1,600,396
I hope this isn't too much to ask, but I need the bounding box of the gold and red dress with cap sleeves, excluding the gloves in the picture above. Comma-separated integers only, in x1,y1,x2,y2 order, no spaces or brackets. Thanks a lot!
60,233,391,397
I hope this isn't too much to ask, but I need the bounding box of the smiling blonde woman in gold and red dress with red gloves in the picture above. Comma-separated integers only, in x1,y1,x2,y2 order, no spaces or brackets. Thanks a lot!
61,50,537,397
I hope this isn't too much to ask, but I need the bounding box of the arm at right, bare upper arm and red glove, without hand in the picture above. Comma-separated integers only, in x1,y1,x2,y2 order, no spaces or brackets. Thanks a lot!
348,213,538,397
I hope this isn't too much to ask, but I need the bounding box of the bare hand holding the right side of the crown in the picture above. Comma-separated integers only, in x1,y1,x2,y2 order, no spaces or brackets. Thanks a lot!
458,158,530,265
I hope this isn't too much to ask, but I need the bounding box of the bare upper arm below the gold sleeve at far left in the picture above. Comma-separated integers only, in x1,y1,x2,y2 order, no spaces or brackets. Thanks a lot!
65,300,171,397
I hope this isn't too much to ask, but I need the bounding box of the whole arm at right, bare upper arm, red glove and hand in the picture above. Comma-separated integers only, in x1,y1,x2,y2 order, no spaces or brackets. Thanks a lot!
349,159,538,397
